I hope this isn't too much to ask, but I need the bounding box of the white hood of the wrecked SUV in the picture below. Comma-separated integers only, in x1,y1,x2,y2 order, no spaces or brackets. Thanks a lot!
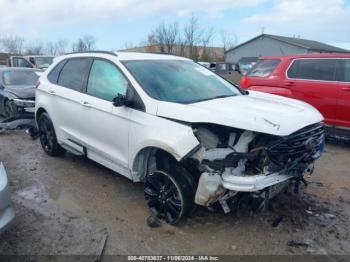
157,91,323,136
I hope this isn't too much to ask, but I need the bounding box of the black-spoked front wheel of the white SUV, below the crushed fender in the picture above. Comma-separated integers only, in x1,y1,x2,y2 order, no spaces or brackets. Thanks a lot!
144,167,195,225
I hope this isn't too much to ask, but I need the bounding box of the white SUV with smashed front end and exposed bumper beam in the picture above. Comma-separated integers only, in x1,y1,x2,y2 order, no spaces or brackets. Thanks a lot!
36,52,324,224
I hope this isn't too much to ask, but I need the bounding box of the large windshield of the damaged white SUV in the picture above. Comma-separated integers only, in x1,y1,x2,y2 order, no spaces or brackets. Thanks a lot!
124,60,240,103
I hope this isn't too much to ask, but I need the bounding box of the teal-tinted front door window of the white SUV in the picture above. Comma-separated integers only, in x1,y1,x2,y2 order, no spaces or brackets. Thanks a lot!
86,60,128,101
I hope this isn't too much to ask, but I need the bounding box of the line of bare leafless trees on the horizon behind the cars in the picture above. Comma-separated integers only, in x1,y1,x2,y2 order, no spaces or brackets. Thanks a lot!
0,14,237,61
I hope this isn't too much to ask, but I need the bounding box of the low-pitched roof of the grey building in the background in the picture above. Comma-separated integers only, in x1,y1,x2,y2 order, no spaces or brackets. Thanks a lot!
225,34,350,53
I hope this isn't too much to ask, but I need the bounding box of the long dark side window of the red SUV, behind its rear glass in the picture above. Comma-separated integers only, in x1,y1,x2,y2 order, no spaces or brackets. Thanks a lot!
287,59,337,81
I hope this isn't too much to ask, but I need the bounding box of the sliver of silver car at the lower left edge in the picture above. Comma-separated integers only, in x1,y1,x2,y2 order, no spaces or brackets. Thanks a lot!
0,162,15,234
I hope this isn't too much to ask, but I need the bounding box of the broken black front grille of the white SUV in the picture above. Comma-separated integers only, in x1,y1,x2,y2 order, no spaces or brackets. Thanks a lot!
268,123,324,164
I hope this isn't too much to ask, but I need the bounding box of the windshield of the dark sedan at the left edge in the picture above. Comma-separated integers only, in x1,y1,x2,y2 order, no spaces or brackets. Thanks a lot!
2,71,39,86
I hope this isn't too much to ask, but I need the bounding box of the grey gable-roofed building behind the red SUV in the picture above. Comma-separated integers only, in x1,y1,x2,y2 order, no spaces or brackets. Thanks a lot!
225,34,349,63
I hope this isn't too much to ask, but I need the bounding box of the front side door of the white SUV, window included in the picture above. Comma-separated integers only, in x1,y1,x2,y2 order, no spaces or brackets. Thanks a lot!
81,59,131,175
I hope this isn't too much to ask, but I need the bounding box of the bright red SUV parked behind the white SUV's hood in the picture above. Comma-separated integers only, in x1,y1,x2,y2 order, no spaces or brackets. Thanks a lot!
240,54,350,129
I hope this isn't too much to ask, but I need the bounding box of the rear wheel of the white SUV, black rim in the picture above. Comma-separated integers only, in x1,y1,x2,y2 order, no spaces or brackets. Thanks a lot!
38,113,65,156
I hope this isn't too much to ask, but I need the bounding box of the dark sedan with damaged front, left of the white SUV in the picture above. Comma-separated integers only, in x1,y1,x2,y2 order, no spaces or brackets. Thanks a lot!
0,67,42,117
